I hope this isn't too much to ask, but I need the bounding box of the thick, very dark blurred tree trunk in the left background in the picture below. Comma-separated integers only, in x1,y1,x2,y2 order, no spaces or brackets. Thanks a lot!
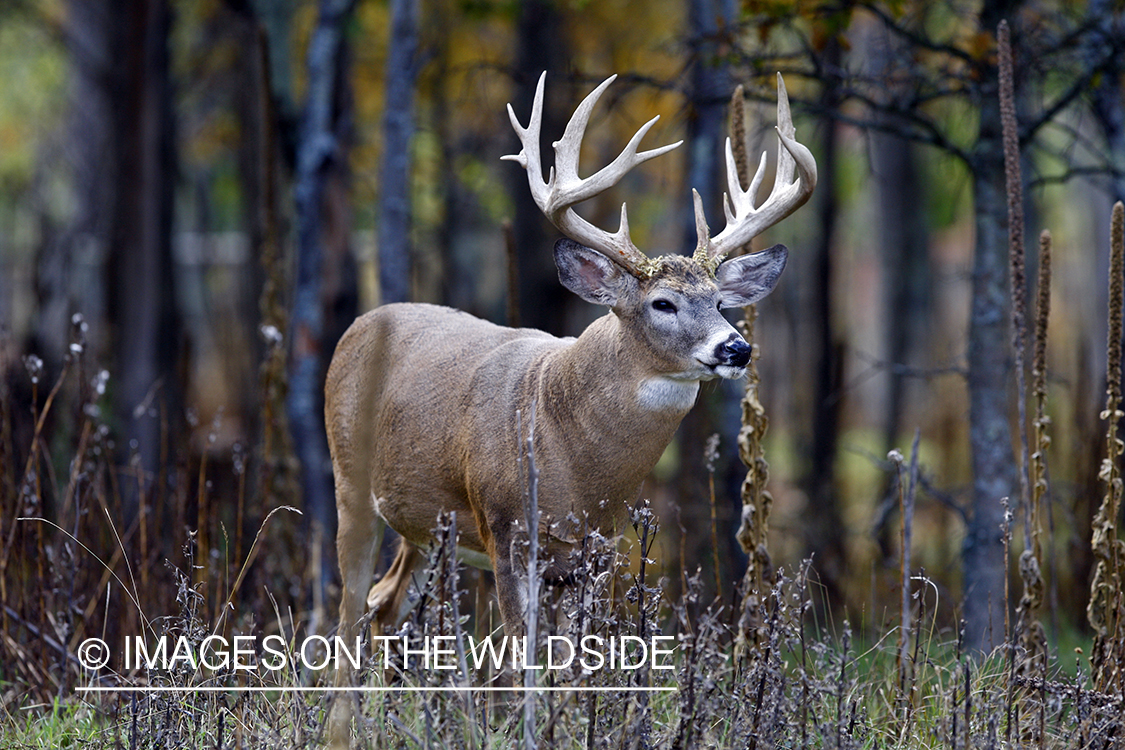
102,0,182,518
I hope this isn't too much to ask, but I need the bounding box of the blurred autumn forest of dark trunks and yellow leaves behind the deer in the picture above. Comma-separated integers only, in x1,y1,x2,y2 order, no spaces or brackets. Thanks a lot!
0,0,1125,728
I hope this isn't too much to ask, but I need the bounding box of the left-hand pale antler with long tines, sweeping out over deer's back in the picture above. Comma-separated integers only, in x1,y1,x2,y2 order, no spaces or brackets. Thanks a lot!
502,73,679,278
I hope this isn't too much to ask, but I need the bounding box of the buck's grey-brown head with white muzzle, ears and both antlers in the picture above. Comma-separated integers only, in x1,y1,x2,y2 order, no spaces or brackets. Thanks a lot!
503,73,817,400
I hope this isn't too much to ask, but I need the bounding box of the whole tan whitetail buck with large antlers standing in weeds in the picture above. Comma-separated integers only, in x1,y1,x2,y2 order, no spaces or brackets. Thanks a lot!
325,70,817,710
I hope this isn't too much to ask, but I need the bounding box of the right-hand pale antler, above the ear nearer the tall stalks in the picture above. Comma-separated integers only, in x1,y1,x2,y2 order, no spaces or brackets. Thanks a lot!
692,73,817,272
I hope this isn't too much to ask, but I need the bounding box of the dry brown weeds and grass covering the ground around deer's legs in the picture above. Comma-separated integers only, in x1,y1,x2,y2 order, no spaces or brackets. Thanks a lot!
0,364,1123,749
